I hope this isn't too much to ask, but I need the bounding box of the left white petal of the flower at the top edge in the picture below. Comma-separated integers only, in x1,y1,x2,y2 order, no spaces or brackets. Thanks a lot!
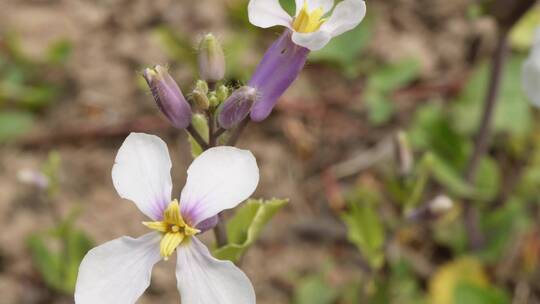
248,0,292,28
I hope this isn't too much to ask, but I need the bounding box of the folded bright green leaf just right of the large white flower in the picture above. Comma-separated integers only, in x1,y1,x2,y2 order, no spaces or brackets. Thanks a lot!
214,199,289,262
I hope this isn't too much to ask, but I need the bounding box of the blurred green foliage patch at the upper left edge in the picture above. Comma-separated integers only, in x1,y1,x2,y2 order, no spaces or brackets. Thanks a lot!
0,34,71,143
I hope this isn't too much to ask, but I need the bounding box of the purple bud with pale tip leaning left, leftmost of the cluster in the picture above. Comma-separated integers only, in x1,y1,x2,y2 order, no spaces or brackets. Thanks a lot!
143,65,191,129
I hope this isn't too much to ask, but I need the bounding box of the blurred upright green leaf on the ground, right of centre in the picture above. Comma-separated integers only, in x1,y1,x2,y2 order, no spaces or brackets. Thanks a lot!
341,189,384,268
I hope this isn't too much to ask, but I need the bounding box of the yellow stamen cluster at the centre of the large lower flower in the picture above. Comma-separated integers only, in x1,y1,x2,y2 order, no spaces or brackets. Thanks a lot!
143,200,201,260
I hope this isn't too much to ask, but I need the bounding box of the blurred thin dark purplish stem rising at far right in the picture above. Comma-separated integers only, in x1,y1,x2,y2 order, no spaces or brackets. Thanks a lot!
464,29,508,250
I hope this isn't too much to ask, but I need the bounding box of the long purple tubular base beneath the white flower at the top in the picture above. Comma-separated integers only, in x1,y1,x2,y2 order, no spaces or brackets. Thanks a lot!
248,30,309,121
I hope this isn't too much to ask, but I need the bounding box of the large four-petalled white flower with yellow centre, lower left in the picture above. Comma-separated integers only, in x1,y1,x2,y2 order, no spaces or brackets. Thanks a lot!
75,133,259,304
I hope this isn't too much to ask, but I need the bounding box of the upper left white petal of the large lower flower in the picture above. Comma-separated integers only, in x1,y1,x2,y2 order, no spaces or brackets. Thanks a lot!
112,133,172,220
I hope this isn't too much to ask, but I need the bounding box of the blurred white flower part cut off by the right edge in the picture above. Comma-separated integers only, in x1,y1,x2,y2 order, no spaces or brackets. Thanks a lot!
522,27,540,107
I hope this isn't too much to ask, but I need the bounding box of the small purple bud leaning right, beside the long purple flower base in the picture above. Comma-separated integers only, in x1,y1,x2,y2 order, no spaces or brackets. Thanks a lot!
218,86,257,129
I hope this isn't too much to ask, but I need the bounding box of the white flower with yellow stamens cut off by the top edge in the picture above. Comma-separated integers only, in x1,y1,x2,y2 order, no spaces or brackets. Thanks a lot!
248,0,366,51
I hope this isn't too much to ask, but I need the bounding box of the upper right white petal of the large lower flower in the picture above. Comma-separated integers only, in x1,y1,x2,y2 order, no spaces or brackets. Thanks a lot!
180,146,259,226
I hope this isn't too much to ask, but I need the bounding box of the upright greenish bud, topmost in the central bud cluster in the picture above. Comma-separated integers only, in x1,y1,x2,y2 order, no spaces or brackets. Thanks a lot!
198,34,225,83
